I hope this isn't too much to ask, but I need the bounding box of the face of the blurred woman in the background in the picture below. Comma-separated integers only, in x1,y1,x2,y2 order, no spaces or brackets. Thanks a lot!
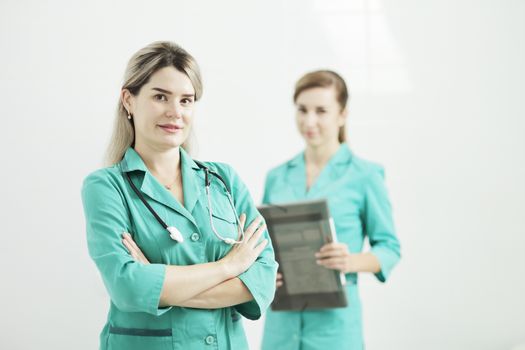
295,87,346,147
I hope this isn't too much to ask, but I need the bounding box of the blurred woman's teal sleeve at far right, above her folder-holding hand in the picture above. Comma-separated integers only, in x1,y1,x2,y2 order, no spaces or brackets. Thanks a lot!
363,168,401,282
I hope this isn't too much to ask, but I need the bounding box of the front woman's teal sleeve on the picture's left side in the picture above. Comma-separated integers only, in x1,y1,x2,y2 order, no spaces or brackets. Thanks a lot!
82,172,169,316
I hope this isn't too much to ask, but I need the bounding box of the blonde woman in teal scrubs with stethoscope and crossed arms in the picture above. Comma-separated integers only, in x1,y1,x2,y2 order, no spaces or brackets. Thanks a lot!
82,42,277,350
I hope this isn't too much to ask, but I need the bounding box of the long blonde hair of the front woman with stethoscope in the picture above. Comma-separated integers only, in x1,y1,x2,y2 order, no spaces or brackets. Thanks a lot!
106,41,202,165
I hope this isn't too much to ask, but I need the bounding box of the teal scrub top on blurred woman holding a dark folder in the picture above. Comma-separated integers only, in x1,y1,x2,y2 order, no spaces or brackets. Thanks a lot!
262,143,400,350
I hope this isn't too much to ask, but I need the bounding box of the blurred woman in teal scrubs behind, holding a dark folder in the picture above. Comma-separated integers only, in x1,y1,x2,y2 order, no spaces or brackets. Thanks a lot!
262,71,400,350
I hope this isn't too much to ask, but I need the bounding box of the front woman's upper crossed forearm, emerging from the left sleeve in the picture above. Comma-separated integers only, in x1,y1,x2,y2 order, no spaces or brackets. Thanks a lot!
159,261,232,307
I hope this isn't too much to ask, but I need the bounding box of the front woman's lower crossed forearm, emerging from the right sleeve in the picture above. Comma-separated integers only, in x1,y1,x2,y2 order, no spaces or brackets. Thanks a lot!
180,277,253,309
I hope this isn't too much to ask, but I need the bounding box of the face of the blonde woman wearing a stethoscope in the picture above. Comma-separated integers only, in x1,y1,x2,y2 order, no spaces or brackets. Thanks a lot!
121,67,195,150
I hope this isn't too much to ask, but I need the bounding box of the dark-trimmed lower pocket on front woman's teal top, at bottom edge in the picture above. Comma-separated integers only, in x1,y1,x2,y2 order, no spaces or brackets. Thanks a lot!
108,326,173,350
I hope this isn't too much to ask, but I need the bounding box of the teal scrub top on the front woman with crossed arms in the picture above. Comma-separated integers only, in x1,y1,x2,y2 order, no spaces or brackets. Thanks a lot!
82,148,277,350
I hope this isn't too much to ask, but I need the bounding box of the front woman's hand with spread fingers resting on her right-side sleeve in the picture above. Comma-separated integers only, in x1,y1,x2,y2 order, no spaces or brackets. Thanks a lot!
220,214,268,278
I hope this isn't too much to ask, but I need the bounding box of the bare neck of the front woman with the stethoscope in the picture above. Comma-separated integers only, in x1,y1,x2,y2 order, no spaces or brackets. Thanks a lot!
135,144,180,183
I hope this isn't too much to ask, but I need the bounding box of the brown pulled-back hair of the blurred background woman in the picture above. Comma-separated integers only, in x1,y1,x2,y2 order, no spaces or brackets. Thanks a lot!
293,70,350,143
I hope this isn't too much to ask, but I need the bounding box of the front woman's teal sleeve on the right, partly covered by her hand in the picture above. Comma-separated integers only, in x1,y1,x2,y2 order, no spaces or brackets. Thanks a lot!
223,165,278,320
